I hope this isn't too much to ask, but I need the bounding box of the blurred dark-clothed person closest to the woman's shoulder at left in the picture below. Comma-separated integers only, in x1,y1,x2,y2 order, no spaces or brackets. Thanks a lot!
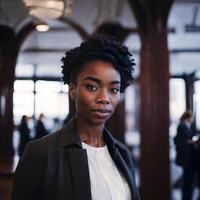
35,113,48,139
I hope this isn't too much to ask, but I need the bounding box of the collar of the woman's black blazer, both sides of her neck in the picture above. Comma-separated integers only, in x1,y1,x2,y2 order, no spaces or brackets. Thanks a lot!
61,117,118,148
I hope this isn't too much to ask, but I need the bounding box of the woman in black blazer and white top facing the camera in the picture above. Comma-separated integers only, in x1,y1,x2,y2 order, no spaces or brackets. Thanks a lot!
12,36,140,200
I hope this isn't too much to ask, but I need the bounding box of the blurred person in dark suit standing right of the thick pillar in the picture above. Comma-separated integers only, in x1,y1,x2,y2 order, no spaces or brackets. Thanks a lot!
174,111,197,200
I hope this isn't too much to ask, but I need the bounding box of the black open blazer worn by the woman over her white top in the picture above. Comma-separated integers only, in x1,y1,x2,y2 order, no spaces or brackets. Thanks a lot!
11,119,140,200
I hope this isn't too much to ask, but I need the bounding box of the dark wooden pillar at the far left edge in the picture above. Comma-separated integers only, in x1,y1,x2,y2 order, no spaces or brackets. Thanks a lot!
0,26,15,162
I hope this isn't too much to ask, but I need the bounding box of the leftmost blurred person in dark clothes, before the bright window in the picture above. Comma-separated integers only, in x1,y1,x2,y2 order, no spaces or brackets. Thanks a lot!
18,115,31,156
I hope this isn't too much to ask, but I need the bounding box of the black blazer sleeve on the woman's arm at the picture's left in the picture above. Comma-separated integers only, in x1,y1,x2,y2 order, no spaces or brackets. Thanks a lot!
11,143,43,200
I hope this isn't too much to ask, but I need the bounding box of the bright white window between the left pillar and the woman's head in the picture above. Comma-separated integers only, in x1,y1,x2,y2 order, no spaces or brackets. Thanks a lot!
13,80,69,132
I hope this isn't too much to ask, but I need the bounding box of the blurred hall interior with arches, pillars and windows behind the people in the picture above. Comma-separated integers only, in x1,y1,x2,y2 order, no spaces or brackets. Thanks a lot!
0,0,200,200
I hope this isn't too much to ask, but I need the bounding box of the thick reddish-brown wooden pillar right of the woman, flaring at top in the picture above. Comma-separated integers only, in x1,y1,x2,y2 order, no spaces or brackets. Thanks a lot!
129,0,172,200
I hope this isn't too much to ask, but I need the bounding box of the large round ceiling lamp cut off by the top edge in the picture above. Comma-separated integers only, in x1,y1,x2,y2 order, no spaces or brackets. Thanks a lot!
23,0,73,20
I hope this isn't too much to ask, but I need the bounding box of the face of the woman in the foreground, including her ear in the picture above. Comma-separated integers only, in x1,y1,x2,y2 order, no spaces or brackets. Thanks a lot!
69,61,121,125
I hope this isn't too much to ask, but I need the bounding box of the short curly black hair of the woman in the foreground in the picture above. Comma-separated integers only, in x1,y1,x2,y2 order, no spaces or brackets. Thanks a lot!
61,35,135,92
